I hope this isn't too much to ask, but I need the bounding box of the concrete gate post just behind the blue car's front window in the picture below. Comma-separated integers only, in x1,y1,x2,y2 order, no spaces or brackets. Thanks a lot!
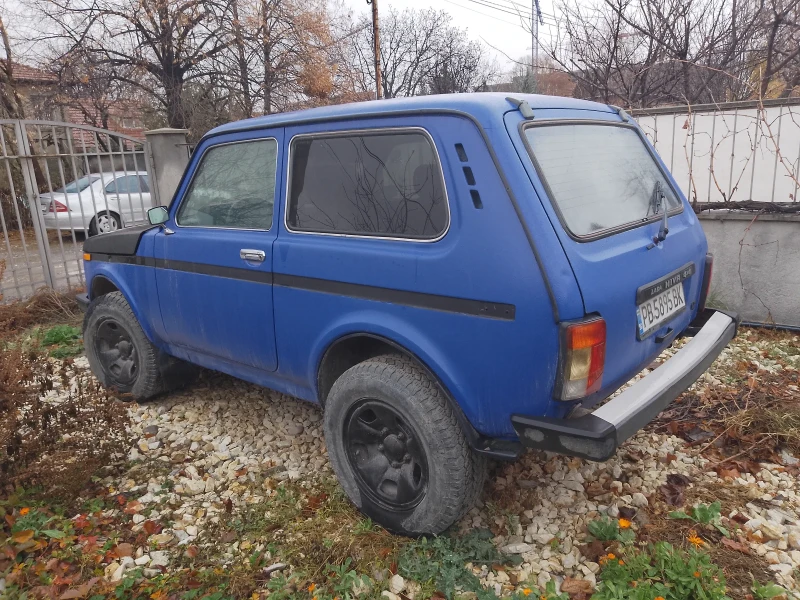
144,128,189,206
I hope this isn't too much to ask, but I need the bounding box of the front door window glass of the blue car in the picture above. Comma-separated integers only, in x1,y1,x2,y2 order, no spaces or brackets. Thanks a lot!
177,138,278,230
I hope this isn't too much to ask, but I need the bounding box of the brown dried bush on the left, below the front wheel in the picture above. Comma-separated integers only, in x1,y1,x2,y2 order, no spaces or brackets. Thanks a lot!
0,348,131,504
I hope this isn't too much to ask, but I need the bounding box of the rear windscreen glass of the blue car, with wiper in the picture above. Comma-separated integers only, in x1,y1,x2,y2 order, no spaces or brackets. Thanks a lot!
525,124,681,237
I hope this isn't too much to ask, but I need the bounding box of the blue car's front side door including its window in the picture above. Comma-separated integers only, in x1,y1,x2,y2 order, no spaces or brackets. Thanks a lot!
154,130,283,371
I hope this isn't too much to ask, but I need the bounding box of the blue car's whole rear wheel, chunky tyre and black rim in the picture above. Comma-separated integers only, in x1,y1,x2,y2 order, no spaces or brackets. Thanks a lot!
324,354,486,536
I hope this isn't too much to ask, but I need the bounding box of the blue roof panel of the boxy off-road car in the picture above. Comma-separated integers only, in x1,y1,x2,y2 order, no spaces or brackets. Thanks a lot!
206,92,612,136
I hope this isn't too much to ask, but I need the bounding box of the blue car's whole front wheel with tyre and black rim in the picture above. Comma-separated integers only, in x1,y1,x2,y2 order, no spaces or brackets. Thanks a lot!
83,292,166,400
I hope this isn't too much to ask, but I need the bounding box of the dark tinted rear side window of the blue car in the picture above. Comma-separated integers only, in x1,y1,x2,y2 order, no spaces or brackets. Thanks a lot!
287,131,450,240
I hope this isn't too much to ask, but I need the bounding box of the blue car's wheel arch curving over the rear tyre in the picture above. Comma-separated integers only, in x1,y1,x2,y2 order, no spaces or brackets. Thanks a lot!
315,331,484,447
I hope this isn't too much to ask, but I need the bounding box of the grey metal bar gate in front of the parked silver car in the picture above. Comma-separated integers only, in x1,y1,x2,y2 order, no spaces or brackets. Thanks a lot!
0,119,148,302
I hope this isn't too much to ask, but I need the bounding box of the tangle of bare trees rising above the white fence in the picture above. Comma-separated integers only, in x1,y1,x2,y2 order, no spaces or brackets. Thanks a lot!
544,0,800,107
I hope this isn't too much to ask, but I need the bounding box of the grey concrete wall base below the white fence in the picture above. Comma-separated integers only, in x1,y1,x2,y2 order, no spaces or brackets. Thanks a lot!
699,211,800,327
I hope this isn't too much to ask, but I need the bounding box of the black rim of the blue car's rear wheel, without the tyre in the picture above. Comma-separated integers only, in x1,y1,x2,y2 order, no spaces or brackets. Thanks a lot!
344,398,428,510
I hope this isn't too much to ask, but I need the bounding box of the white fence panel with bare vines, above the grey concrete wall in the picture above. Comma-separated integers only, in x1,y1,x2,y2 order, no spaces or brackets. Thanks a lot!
632,98,800,203
